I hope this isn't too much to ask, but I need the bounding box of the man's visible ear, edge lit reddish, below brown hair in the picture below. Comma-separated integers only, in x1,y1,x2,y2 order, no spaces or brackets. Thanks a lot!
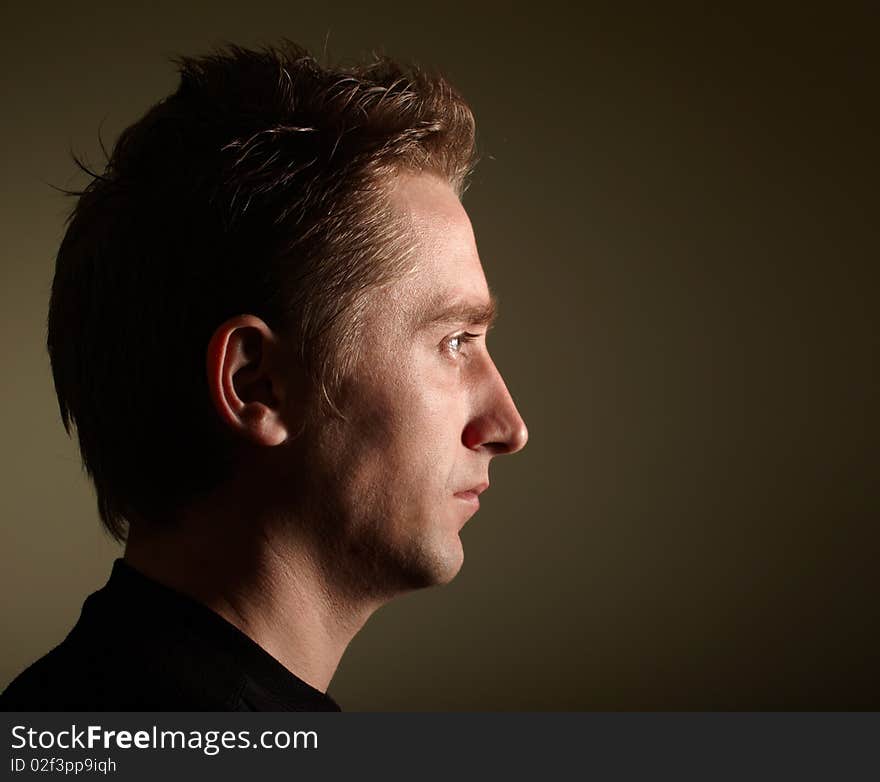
207,315,288,446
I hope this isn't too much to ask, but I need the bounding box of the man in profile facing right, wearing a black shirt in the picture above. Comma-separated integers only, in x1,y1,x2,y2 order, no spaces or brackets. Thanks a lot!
2,43,527,710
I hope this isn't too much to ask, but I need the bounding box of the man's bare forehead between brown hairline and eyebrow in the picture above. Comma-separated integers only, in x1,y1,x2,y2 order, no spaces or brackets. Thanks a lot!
391,174,492,320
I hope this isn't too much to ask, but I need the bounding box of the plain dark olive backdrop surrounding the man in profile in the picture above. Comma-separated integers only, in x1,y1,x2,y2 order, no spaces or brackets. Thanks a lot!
0,0,880,710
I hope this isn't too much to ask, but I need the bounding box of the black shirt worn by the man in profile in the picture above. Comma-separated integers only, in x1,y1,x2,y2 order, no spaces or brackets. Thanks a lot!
0,559,340,711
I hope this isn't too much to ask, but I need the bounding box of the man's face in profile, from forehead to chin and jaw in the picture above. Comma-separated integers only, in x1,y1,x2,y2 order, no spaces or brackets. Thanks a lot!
288,174,528,593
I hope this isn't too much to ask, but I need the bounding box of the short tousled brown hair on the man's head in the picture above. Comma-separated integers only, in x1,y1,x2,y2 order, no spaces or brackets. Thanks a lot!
47,41,475,540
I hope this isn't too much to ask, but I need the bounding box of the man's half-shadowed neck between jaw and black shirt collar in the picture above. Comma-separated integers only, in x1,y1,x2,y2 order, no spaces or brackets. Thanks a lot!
124,502,384,692
